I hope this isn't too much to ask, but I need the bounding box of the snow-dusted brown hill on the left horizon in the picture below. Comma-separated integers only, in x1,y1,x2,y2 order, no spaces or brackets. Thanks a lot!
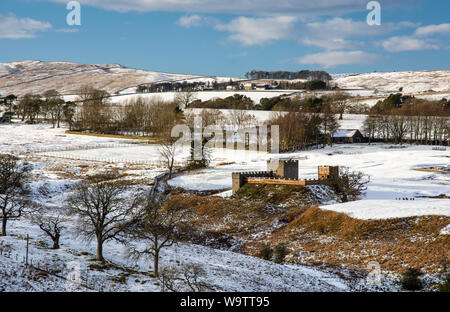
0,61,241,95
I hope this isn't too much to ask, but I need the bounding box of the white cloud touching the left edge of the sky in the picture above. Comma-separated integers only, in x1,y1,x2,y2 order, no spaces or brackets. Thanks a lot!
0,14,52,39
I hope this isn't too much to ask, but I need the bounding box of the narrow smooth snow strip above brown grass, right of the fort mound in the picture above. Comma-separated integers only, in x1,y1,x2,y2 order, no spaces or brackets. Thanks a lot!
320,199,450,220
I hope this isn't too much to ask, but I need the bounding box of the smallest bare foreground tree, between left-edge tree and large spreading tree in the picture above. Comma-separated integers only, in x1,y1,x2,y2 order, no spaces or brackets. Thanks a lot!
31,207,65,249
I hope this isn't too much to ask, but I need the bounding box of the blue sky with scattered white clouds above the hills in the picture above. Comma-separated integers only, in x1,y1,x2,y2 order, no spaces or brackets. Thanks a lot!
0,0,450,77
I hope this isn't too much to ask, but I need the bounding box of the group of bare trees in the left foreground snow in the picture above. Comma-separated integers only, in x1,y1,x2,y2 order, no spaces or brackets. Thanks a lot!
0,154,189,276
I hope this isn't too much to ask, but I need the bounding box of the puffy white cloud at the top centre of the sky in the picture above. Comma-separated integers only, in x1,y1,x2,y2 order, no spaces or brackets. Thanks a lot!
215,16,297,46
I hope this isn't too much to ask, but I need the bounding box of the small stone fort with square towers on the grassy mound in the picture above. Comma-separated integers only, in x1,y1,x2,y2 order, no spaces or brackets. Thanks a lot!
232,158,339,194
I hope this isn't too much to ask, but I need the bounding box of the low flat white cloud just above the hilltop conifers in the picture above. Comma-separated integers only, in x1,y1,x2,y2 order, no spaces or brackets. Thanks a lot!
298,51,378,68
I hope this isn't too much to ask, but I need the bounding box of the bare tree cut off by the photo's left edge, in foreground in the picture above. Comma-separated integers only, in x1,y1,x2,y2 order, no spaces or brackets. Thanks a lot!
0,154,31,236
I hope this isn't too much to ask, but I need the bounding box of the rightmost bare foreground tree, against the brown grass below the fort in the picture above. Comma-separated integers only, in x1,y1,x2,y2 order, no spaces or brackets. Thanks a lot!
128,196,185,276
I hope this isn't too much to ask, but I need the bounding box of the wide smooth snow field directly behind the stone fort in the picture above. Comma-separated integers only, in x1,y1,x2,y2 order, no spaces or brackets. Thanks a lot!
169,144,450,199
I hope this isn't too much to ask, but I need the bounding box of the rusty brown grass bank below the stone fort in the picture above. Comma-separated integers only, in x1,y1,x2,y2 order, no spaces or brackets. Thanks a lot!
171,190,450,273
